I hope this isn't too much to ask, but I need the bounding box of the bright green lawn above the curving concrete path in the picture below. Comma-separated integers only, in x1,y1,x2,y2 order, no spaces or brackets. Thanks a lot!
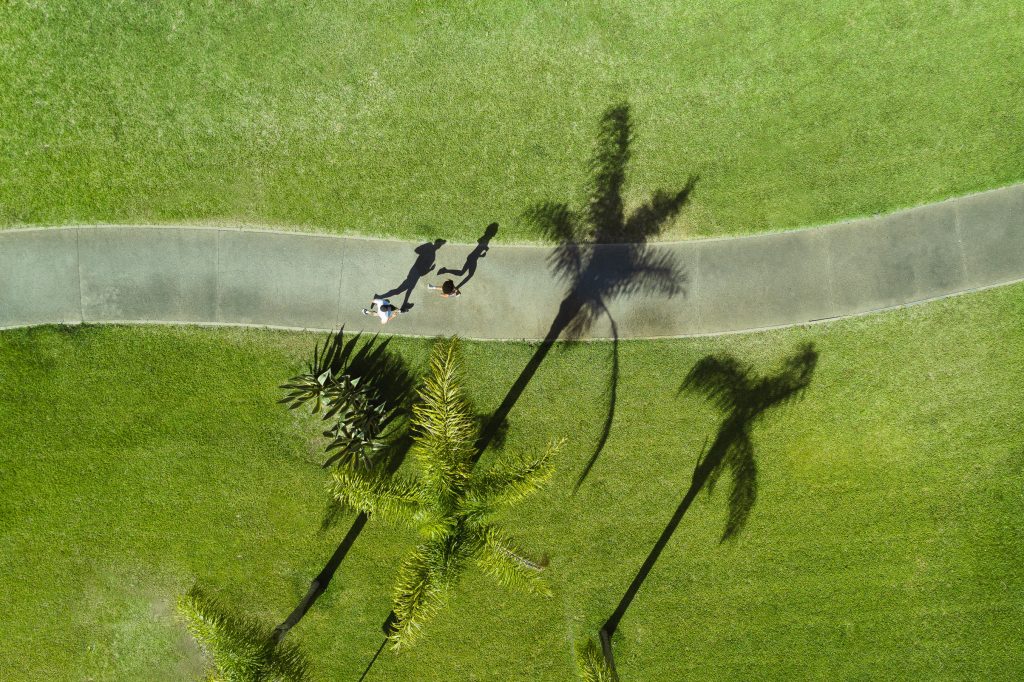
0,0,1024,242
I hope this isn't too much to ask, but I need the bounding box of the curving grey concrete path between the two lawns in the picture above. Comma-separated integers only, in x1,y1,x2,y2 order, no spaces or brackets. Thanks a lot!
0,184,1024,339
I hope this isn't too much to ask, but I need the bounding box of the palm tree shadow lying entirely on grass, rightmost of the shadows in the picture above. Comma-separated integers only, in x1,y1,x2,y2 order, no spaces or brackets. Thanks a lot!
598,344,818,679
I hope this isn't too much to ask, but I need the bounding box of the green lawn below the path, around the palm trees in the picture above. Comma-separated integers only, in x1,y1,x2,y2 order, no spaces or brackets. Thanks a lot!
0,285,1024,680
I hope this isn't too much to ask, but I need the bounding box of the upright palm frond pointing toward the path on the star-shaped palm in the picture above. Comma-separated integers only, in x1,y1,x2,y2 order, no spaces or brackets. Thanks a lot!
413,338,476,498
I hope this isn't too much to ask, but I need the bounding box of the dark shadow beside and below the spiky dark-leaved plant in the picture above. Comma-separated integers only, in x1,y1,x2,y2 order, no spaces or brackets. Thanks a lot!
273,330,416,642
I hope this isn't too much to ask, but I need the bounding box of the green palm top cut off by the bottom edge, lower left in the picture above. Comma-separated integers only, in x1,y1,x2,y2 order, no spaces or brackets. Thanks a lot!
177,585,306,682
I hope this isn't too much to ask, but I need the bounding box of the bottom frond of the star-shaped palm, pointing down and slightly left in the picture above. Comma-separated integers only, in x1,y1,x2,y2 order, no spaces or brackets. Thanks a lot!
388,538,458,650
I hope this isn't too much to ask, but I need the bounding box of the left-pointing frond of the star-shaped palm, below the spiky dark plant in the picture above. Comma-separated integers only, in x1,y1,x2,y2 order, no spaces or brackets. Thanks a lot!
329,469,421,525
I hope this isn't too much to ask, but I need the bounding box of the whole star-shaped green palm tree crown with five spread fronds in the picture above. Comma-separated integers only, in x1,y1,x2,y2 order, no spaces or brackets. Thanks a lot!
333,339,561,649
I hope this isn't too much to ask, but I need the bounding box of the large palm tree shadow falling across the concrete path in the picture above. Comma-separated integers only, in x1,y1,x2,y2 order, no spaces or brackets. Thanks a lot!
477,103,697,475
